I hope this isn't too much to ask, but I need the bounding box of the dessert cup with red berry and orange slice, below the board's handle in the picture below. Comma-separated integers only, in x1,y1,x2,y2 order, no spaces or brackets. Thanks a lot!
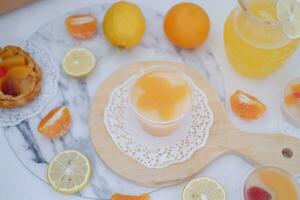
244,167,300,200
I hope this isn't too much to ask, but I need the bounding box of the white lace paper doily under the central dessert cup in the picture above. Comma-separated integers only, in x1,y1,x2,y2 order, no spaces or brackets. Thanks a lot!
104,72,213,168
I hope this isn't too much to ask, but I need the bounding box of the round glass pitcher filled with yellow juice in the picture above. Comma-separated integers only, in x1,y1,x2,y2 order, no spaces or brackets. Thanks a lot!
224,0,299,79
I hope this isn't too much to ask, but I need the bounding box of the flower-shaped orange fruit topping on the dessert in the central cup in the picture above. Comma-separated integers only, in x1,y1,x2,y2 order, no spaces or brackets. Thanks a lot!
137,75,188,120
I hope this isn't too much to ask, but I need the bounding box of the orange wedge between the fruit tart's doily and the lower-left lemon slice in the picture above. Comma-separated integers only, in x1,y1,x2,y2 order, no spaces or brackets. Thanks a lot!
38,106,71,139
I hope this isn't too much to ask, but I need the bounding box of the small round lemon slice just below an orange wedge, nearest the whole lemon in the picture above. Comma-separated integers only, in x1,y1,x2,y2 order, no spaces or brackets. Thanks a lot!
63,48,96,77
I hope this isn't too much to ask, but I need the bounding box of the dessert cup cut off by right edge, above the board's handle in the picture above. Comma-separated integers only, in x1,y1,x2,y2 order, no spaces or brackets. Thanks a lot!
281,77,300,129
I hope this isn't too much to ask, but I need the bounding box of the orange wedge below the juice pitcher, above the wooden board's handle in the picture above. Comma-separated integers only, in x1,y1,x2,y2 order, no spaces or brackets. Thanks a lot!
230,90,266,120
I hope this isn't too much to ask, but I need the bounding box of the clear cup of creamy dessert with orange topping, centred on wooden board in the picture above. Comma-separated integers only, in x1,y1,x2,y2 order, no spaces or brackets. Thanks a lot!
130,66,193,136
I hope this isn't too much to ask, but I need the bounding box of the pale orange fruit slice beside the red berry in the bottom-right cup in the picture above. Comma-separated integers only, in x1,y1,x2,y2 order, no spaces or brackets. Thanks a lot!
259,171,298,200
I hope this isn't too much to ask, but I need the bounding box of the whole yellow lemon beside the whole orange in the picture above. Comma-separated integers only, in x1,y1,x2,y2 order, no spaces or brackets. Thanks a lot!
102,1,146,48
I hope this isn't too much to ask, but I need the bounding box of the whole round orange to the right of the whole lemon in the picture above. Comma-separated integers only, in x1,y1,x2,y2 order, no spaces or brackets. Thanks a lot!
164,3,210,49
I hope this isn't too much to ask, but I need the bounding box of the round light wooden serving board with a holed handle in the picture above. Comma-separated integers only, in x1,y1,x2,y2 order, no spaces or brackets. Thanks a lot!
89,61,300,187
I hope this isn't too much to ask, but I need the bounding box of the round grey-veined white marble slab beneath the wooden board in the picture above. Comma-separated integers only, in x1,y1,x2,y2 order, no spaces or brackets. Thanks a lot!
4,4,224,199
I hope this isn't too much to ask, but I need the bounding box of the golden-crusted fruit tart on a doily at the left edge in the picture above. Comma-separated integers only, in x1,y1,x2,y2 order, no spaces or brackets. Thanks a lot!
0,46,42,108
